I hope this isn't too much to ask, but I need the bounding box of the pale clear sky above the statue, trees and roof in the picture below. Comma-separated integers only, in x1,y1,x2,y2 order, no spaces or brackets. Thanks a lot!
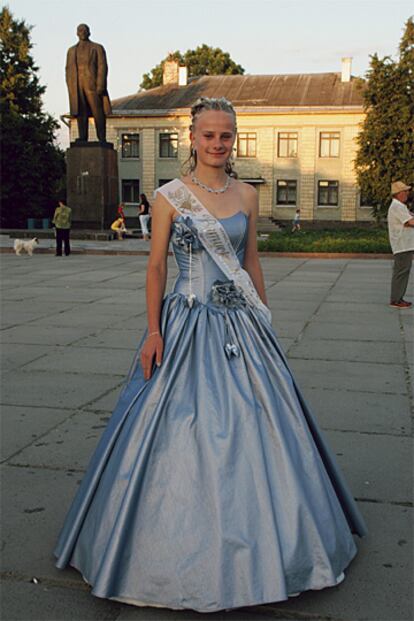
6,0,414,147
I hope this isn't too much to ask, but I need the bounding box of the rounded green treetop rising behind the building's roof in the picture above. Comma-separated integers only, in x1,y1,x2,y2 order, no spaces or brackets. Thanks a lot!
140,43,244,89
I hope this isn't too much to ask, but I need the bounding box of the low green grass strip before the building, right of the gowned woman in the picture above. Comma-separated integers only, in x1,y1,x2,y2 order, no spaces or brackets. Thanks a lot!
258,228,391,253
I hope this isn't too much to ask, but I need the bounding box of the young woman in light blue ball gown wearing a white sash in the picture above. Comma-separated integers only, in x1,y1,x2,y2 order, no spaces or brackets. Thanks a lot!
56,98,365,612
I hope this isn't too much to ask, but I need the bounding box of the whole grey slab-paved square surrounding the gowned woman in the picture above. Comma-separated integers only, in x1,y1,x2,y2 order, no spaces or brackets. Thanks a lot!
0,253,414,621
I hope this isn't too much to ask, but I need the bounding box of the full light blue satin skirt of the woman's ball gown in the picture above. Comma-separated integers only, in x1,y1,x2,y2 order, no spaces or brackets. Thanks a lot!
55,293,366,612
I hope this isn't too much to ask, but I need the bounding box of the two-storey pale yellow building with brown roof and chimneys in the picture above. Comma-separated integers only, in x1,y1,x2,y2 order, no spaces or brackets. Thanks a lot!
71,59,372,222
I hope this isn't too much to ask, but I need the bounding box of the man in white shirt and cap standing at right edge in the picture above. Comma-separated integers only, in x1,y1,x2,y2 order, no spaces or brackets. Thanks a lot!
387,181,414,308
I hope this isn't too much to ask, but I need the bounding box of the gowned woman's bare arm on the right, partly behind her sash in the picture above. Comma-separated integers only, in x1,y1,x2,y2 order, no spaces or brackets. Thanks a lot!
239,184,267,306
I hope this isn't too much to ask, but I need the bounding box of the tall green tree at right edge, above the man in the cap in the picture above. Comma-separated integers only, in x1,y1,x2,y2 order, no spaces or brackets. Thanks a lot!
355,18,414,221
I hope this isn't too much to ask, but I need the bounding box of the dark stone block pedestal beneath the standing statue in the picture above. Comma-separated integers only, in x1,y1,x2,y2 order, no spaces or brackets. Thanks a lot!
66,141,119,230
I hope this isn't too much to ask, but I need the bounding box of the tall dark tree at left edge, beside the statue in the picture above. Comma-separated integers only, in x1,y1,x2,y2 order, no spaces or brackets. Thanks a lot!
0,7,65,227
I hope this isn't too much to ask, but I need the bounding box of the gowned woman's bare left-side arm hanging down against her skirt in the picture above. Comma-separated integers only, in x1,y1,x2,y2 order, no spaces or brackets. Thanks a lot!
141,194,174,379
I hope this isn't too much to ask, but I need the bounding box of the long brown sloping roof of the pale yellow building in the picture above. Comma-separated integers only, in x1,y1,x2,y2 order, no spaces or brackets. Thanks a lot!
112,73,363,115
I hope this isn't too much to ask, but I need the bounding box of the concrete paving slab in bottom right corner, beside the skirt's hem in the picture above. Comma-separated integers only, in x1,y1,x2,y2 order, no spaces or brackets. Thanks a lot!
266,502,414,621
